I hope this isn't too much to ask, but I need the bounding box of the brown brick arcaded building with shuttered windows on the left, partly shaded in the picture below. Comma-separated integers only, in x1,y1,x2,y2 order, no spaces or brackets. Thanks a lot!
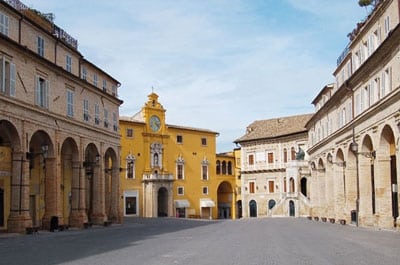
0,0,122,232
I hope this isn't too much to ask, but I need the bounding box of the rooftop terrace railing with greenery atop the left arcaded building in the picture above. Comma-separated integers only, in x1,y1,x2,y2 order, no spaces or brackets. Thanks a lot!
3,0,78,50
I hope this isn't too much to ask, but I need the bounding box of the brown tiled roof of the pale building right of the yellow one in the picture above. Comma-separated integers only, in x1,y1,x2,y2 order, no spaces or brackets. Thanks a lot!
235,114,313,143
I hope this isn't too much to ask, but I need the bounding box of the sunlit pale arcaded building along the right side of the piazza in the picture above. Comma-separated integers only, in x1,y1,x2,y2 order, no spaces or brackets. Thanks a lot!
307,0,400,228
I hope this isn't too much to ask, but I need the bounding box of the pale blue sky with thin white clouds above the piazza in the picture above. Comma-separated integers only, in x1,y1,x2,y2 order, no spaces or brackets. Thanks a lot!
23,0,366,152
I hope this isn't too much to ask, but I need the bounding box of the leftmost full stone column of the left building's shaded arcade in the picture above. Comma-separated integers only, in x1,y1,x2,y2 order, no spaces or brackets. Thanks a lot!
7,152,32,233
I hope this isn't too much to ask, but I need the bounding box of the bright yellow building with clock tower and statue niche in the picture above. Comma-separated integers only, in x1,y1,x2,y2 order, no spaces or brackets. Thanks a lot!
120,93,235,219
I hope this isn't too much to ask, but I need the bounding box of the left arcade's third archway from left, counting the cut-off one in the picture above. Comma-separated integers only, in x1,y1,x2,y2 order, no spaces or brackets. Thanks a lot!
60,138,81,225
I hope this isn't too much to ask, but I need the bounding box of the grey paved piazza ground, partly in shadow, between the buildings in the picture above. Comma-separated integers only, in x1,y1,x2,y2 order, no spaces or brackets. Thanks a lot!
0,218,400,265
